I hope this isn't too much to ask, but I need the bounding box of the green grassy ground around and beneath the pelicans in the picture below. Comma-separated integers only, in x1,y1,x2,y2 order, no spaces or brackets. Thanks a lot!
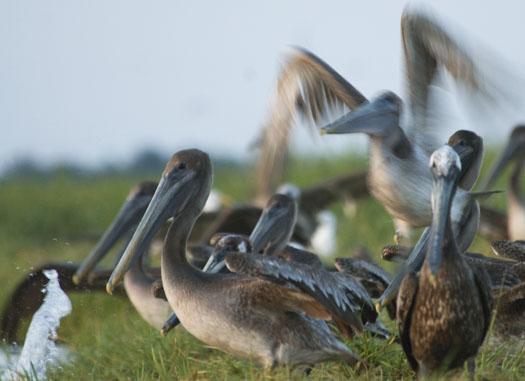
0,153,525,380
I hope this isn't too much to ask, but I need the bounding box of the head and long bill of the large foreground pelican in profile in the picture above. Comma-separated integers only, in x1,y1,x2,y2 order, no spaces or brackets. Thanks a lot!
106,149,212,294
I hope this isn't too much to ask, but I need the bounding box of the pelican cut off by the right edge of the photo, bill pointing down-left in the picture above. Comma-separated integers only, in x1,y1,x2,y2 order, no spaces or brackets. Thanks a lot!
483,125,525,240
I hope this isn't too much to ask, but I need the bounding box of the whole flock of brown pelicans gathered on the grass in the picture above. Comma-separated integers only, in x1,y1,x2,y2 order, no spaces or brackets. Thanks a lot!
2,10,525,376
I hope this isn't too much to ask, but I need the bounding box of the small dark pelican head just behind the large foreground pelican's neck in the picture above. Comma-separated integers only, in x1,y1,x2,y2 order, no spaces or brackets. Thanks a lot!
202,233,252,273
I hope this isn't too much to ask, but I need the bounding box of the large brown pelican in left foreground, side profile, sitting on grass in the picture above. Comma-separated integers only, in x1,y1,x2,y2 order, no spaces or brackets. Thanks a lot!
107,149,366,367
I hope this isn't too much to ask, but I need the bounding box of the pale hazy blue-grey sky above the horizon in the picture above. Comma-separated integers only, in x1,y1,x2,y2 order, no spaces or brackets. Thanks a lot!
0,0,525,168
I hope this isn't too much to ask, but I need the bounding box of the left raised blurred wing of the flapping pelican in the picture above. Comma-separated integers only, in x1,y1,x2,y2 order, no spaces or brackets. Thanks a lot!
257,48,366,203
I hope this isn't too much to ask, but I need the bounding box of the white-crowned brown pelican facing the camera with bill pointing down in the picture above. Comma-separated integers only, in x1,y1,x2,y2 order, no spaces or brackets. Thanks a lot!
397,146,492,376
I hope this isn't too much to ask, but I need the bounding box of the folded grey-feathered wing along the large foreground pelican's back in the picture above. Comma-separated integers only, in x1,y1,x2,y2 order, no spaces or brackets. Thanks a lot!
225,253,377,332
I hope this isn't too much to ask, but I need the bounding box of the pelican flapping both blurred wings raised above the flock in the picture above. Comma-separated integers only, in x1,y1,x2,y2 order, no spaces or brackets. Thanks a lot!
254,10,485,238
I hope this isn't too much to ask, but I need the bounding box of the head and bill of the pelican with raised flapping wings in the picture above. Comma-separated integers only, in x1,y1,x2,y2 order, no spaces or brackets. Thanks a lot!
321,91,403,137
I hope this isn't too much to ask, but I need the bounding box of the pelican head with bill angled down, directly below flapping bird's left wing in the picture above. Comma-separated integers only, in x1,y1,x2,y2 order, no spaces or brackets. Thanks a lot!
250,194,297,255
